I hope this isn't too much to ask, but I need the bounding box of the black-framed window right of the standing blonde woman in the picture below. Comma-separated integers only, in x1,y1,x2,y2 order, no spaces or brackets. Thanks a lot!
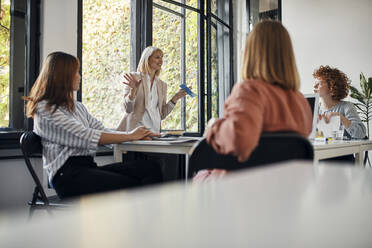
152,0,233,135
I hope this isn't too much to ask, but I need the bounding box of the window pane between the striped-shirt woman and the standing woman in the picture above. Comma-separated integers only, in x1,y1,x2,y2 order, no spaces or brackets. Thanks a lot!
82,0,131,128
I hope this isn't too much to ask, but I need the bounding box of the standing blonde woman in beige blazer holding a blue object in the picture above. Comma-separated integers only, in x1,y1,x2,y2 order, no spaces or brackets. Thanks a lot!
118,46,186,132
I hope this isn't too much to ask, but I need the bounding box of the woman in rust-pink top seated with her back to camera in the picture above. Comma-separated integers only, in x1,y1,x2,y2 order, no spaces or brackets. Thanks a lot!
206,20,312,165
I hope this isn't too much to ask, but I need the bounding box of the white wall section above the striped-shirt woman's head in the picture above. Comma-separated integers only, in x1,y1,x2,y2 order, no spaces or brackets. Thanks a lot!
40,0,77,60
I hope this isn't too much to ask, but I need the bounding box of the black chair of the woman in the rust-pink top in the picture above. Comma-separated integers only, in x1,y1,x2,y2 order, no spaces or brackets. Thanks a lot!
188,132,314,177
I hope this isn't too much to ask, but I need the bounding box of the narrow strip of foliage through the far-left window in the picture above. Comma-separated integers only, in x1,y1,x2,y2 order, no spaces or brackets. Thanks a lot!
0,1,10,127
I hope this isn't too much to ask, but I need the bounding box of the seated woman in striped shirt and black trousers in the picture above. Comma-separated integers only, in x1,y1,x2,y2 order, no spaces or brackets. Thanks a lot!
25,52,162,198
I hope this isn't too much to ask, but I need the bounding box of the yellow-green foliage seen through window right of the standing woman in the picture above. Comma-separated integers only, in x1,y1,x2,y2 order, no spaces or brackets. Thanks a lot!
152,0,218,132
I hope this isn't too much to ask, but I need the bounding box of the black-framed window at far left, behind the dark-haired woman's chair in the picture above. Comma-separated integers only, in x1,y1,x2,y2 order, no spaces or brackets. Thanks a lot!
0,0,40,149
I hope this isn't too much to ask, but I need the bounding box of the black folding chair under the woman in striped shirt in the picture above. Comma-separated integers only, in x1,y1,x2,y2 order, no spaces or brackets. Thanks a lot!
20,131,70,218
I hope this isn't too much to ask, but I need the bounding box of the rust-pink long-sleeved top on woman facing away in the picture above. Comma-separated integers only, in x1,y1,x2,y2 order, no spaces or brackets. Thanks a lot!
207,80,312,161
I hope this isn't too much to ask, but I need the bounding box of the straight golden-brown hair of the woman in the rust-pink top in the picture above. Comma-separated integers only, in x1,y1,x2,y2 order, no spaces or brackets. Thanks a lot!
242,20,300,90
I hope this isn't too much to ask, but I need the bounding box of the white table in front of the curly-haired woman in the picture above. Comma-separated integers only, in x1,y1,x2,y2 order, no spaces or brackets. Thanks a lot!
312,140,372,166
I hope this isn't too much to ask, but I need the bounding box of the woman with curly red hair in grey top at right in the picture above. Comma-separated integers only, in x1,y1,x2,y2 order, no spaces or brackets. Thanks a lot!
313,65,366,139
